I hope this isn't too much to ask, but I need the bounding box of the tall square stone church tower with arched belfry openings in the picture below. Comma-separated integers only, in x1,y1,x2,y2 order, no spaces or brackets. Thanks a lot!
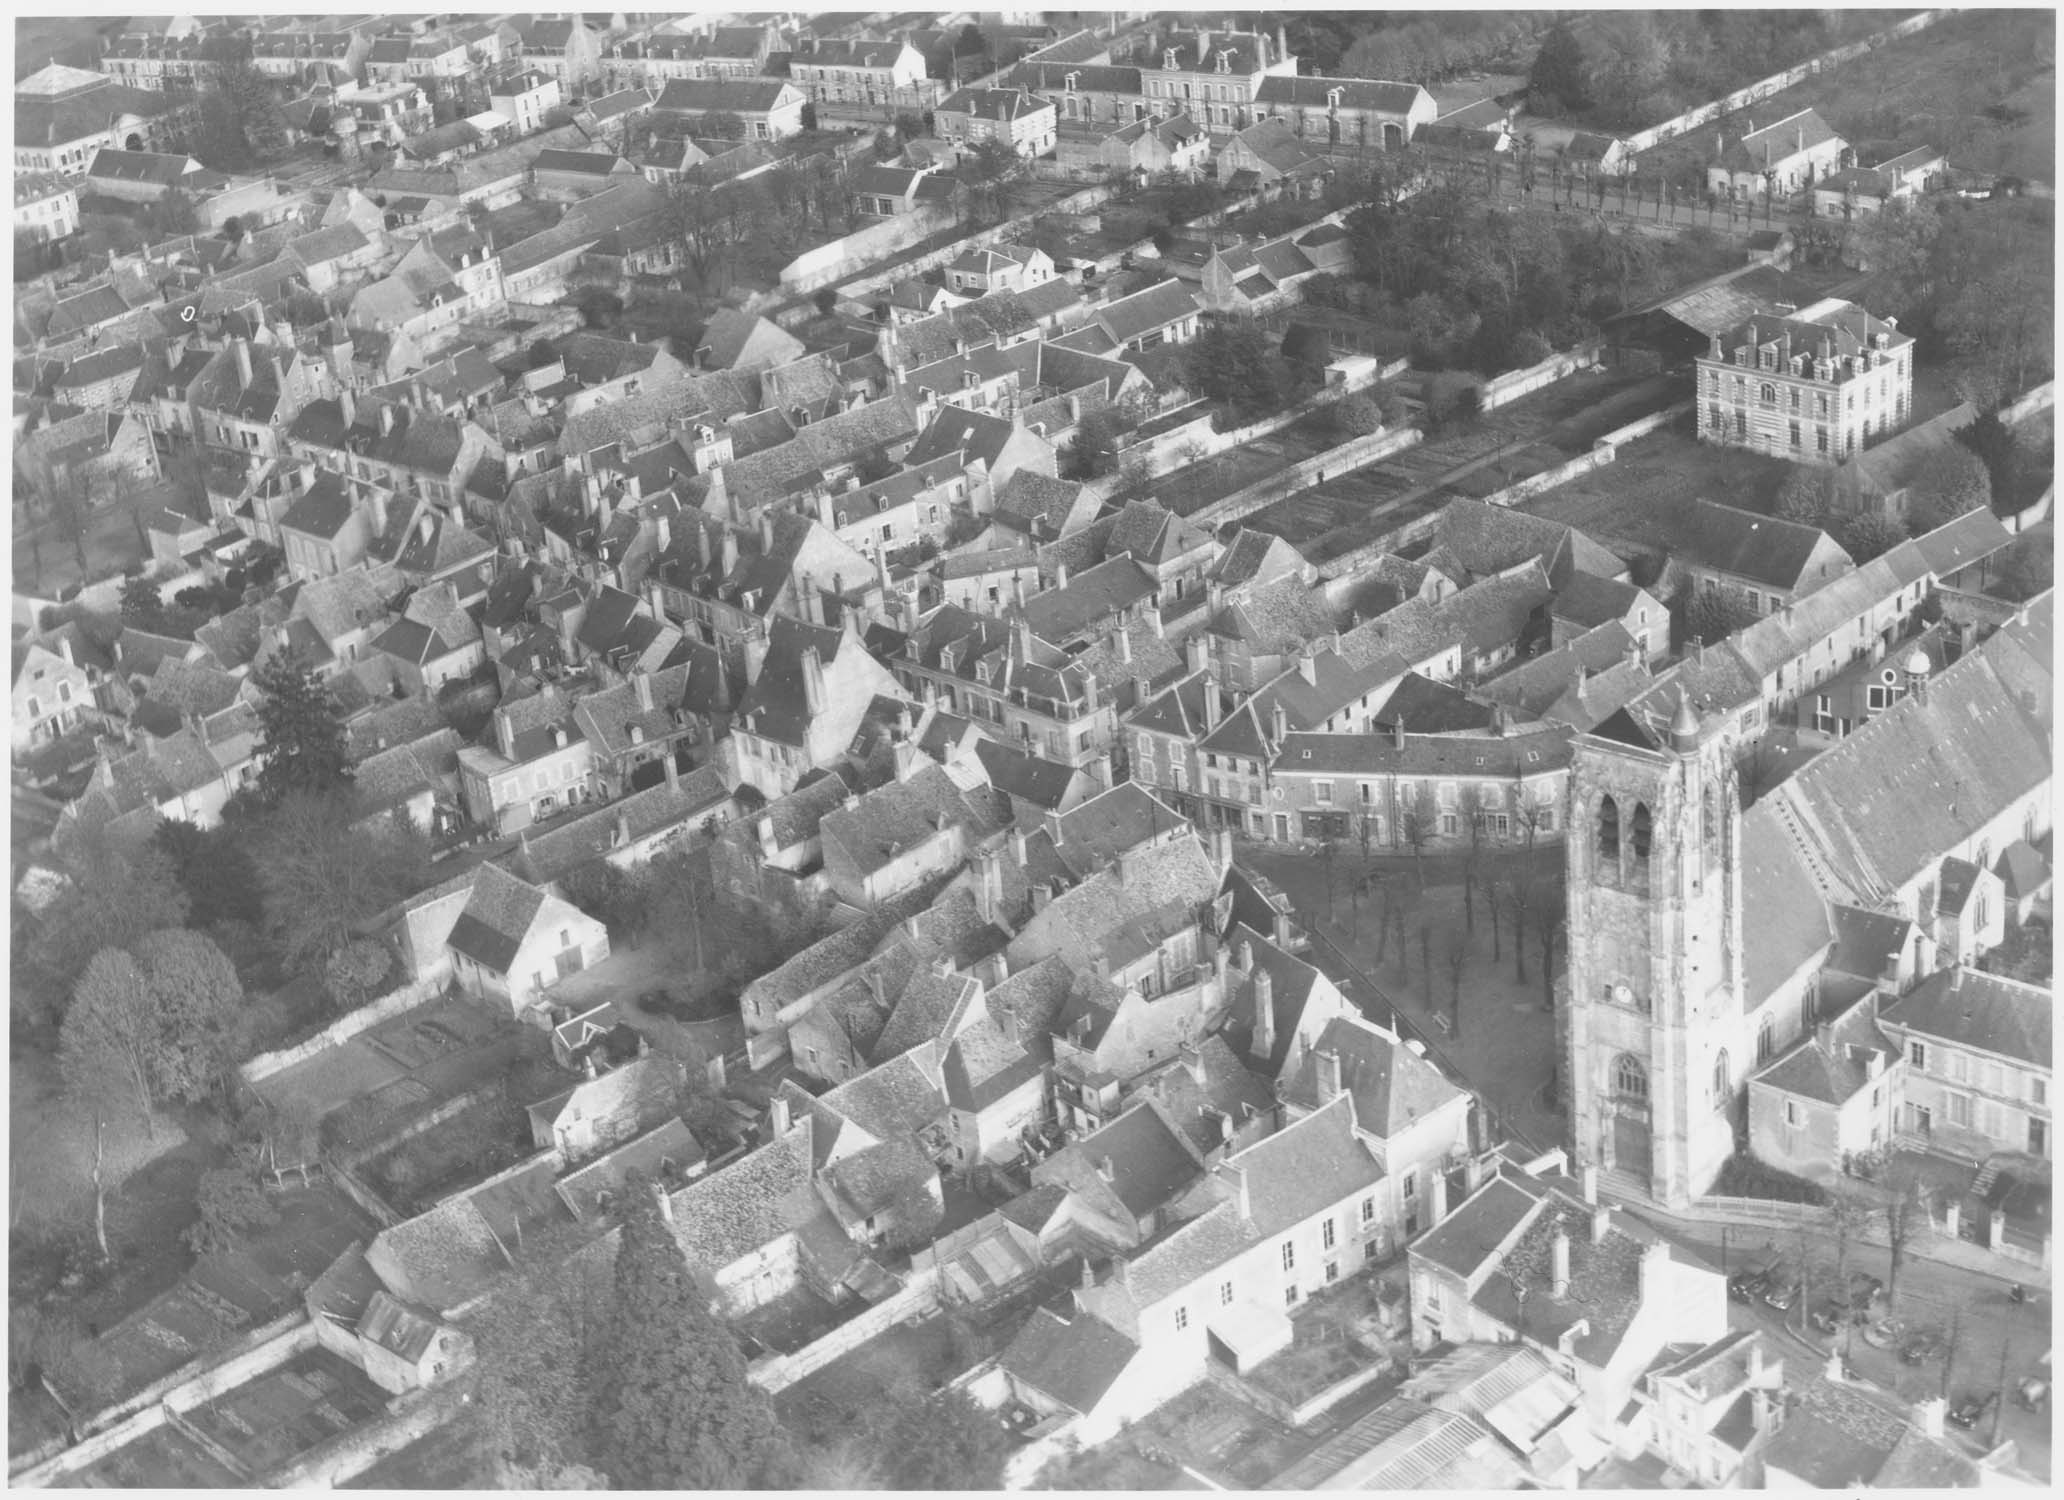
1556,695,1750,1205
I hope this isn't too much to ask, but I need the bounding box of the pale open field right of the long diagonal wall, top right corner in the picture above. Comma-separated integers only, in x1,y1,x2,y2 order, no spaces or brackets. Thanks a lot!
1635,10,2056,182
